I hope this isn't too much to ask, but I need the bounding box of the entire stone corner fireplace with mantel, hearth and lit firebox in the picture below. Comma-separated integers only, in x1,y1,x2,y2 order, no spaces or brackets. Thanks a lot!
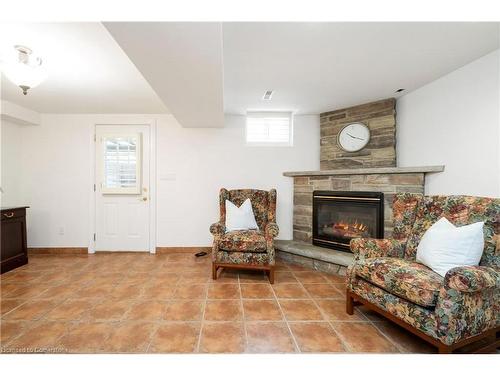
275,98,444,274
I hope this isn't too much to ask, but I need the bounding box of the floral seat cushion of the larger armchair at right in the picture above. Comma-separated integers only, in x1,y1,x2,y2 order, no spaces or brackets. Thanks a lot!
354,257,444,307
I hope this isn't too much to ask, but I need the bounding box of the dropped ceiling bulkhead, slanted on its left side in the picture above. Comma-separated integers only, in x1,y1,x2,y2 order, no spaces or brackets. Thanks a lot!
104,22,224,127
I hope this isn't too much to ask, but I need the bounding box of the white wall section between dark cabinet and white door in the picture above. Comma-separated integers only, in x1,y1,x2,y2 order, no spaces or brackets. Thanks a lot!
11,115,92,247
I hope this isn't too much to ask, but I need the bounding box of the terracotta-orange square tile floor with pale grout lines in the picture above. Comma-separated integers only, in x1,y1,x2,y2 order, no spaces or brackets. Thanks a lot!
0,253,435,353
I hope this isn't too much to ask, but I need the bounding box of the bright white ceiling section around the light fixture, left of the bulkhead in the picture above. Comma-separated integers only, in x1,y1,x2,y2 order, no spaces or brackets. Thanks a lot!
0,22,168,113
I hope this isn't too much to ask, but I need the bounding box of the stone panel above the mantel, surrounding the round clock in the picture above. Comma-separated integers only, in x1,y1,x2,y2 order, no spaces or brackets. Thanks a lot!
320,98,396,170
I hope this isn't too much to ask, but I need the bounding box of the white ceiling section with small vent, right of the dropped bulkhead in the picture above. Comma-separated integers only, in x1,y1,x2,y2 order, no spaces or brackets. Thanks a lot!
223,22,499,113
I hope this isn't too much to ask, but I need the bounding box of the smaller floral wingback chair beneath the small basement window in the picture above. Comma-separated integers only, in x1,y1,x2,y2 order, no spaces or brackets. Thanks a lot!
210,188,279,284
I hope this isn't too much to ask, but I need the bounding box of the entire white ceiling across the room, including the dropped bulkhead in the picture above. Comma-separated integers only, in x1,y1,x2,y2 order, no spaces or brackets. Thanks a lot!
0,22,500,127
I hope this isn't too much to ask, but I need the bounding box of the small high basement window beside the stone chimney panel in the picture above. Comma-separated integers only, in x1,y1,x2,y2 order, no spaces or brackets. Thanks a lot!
246,112,293,146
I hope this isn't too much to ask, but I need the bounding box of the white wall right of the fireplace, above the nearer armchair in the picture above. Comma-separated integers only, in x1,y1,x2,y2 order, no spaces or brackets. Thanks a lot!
397,50,500,197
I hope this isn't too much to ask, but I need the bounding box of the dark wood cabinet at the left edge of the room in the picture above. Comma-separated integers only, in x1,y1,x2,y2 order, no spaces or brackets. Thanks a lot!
0,207,28,273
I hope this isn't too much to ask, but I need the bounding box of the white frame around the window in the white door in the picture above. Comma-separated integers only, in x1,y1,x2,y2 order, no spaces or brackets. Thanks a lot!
99,133,142,195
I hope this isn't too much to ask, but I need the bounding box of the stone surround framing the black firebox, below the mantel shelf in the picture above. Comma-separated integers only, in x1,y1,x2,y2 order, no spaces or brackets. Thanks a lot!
293,173,425,243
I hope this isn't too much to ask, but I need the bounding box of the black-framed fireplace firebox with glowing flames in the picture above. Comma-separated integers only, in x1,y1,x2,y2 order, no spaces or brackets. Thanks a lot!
312,190,384,252
